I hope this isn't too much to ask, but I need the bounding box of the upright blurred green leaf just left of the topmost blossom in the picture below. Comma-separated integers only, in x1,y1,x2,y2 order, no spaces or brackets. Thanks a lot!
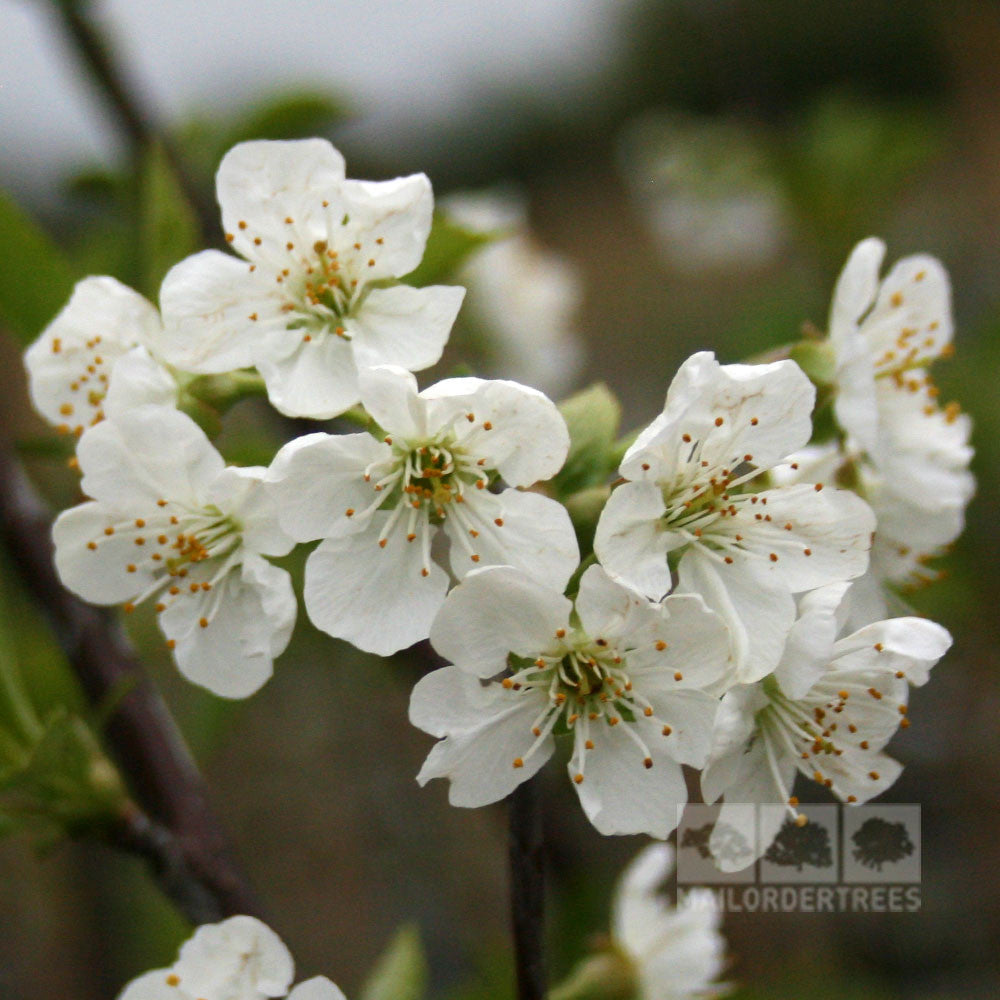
139,144,199,298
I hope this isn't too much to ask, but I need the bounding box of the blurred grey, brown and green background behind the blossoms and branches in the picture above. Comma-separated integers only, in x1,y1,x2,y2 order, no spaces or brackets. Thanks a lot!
0,0,1000,1000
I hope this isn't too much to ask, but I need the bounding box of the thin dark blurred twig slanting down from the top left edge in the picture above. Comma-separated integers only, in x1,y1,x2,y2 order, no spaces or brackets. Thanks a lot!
53,0,222,244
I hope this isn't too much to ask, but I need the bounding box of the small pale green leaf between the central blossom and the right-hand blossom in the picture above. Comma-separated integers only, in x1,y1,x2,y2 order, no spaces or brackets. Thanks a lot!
554,382,621,497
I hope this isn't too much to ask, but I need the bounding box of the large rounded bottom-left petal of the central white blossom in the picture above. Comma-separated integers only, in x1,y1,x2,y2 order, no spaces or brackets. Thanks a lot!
305,512,448,656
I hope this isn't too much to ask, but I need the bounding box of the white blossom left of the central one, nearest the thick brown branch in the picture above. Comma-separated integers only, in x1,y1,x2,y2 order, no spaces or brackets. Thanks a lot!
53,406,296,698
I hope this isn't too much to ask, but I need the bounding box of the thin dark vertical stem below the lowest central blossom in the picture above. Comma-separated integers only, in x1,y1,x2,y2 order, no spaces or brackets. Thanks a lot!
508,778,546,1000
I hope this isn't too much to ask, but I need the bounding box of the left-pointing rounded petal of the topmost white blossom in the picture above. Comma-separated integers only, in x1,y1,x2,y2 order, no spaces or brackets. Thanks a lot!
158,250,276,374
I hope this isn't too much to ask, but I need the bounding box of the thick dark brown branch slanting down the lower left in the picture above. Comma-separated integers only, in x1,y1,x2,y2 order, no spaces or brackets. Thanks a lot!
0,441,260,923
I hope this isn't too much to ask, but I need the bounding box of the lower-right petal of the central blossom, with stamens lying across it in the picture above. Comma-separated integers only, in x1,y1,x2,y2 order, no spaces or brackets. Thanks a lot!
444,490,580,592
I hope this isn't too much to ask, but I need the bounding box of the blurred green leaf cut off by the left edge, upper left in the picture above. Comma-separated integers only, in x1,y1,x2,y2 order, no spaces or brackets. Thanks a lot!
0,191,77,345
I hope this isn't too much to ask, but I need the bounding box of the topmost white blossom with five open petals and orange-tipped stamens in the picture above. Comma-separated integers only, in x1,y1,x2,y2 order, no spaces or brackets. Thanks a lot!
160,139,464,418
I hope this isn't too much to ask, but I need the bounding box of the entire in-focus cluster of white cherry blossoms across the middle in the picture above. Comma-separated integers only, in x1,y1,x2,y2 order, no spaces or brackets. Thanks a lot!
26,140,973,876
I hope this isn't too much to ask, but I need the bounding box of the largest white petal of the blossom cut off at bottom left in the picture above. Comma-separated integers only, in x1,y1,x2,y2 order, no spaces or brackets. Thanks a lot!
173,916,294,1000
